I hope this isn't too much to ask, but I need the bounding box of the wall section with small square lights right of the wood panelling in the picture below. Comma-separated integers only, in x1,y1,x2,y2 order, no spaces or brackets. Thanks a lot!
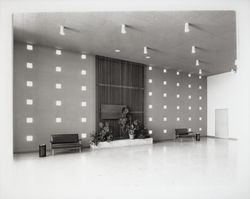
144,67,207,141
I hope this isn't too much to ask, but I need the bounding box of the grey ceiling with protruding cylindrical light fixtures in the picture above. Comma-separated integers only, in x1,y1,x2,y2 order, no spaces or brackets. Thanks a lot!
13,11,236,76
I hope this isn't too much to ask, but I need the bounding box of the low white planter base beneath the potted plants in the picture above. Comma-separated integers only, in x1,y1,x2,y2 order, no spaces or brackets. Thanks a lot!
90,138,153,149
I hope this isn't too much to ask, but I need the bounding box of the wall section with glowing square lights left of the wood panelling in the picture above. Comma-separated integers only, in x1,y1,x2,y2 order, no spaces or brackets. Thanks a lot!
13,42,95,152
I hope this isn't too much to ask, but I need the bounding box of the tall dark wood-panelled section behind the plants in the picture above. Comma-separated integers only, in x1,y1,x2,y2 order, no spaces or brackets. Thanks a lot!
96,56,145,140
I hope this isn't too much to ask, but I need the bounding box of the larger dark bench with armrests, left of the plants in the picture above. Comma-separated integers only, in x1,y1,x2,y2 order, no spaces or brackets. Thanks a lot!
50,134,82,155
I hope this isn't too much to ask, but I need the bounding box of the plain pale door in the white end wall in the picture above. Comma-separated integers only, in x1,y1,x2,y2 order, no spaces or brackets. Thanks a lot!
215,109,228,138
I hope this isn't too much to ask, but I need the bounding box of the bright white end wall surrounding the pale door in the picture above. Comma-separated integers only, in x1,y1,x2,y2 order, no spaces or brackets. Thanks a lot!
207,72,241,138
